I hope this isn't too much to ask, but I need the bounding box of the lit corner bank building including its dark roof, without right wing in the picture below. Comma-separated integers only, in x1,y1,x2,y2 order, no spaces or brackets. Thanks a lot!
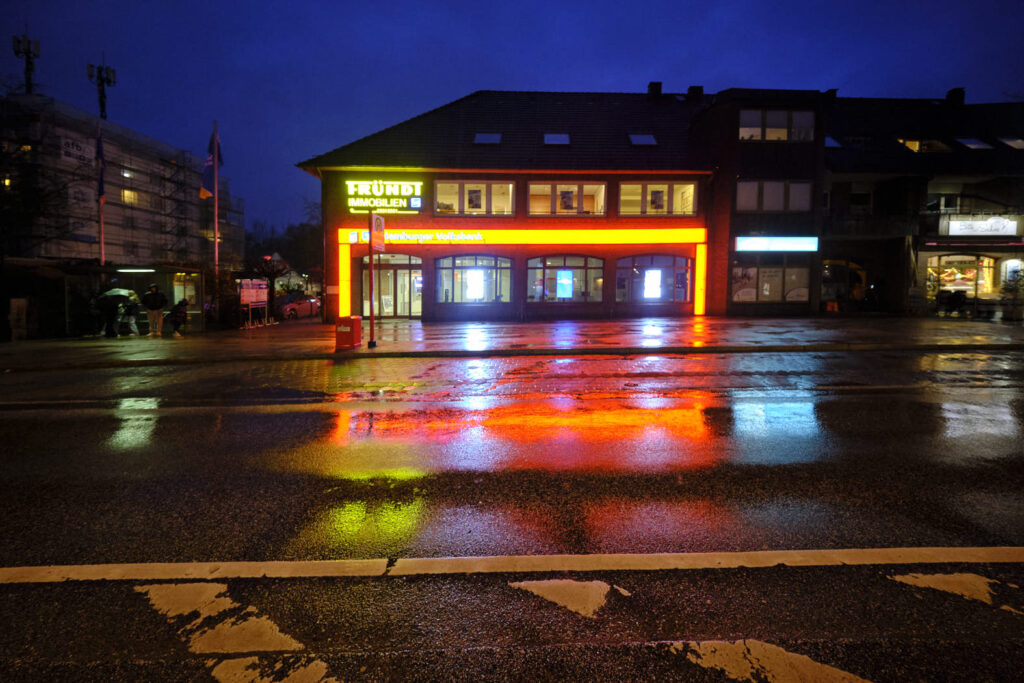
300,92,725,321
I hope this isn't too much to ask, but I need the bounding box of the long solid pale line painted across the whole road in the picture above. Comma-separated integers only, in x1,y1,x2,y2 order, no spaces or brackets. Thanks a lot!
0,546,1024,585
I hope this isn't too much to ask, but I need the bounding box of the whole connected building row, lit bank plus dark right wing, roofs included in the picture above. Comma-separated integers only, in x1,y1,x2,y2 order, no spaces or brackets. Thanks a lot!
299,83,1024,321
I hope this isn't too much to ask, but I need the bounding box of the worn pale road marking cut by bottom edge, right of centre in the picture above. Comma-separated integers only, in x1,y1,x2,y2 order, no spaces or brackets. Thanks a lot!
672,640,867,683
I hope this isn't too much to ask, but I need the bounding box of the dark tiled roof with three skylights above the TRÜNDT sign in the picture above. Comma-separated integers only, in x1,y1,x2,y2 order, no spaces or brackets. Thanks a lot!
298,90,699,171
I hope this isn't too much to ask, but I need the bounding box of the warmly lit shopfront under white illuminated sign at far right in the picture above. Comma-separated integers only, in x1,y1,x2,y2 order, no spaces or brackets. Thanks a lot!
918,215,1024,317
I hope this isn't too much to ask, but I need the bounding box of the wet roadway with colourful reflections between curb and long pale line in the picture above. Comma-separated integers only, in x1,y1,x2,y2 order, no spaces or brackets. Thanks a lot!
0,350,1024,561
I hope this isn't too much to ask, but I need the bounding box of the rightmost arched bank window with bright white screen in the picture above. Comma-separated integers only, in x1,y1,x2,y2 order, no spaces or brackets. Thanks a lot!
615,254,693,303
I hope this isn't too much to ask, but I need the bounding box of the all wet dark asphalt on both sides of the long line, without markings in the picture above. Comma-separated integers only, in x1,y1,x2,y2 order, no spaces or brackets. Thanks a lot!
0,323,1024,680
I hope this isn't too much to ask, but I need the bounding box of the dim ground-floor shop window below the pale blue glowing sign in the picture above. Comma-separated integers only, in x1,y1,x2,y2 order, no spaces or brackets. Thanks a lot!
730,254,811,303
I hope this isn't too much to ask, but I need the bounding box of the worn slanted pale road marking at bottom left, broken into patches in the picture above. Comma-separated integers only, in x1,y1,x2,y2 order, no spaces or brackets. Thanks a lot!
135,583,334,683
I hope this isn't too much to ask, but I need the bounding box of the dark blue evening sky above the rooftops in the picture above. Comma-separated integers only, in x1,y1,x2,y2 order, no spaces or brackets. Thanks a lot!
0,0,1024,228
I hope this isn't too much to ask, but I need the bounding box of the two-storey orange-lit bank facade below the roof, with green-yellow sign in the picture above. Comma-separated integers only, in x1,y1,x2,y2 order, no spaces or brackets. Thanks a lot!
322,168,709,321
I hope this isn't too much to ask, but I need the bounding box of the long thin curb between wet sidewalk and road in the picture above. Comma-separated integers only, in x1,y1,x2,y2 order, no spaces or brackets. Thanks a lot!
0,342,1024,374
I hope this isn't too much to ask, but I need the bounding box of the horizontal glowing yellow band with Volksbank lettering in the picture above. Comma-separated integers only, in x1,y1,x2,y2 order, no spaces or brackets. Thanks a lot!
338,227,708,246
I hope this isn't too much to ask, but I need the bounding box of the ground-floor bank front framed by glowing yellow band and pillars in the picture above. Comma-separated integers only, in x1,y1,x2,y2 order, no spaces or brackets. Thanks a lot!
337,227,707,321
